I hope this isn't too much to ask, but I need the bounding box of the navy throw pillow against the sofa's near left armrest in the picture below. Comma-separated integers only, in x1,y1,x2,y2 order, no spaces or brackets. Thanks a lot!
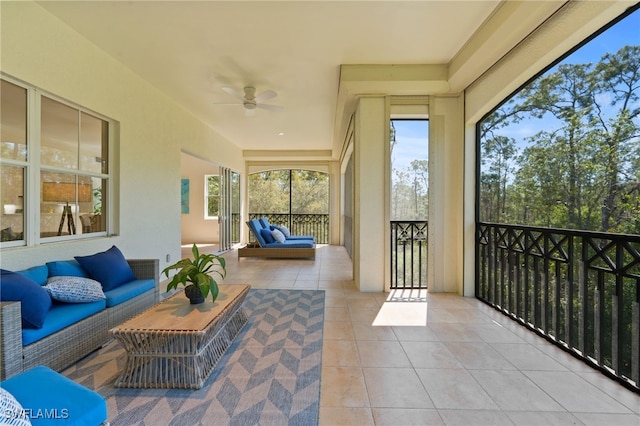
0,269,51,328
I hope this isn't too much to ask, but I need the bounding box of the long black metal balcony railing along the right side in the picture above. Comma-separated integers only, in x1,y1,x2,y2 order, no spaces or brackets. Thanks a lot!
476,223,640,391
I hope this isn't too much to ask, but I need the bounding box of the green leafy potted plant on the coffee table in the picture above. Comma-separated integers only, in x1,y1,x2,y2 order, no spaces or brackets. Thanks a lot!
162,244,227,305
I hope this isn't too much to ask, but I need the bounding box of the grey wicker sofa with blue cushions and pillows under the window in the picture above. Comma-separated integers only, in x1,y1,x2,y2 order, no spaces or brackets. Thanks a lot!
0,246,160,380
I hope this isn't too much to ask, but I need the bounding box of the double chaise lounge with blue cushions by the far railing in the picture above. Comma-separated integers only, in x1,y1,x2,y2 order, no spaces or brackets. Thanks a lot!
238,218,316,259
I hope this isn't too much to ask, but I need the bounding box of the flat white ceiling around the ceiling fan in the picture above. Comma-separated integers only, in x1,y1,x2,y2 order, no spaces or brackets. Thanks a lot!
40,0,562,155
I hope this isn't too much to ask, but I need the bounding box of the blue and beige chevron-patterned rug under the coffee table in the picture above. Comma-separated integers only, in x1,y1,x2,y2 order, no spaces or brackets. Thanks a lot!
63,289,324,426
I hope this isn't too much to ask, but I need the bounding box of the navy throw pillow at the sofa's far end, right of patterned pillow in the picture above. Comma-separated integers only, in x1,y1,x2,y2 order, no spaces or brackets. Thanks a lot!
75,246,136,291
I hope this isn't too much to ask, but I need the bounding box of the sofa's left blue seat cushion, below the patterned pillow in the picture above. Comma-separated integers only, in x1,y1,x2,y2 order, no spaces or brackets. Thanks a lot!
22,300,106,346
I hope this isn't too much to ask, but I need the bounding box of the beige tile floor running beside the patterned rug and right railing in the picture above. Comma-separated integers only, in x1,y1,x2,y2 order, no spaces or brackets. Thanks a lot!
218,246,640,426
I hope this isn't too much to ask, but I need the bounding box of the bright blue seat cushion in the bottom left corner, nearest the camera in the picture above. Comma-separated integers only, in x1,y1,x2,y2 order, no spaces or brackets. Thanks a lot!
0,366,107,426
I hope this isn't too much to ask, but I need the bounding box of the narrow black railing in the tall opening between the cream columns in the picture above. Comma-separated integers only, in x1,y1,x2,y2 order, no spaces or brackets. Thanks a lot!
390,220,429,289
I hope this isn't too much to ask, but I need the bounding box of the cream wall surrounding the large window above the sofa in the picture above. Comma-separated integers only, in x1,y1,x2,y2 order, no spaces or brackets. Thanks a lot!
0,2,244,269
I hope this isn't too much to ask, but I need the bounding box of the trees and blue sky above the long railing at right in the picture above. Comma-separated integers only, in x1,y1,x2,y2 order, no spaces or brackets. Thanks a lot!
479,46,640,234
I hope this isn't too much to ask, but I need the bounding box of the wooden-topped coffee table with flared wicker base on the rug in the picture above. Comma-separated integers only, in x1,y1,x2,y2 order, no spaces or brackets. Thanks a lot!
110,284,251,389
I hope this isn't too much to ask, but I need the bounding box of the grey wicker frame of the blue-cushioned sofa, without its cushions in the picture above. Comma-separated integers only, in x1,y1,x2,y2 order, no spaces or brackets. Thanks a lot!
0,259,160,380
